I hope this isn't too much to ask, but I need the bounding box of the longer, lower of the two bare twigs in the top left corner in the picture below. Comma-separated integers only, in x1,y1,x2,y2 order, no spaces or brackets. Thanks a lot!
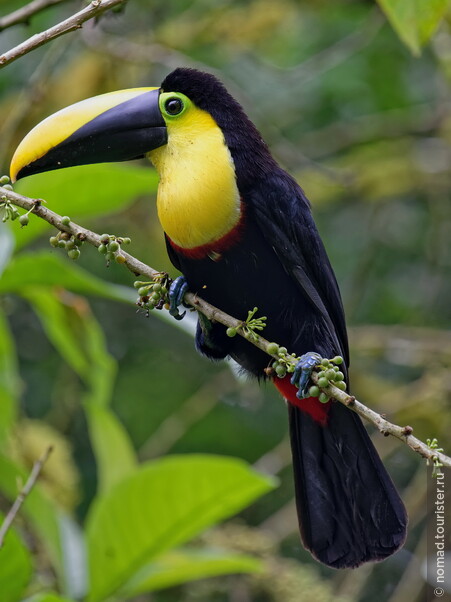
0,0,126,67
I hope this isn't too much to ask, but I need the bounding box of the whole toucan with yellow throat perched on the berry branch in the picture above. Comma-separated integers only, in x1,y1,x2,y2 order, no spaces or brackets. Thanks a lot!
11,68,407,569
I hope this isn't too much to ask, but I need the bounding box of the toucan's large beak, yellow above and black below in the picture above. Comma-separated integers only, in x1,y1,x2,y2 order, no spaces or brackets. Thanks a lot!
11,88,167,182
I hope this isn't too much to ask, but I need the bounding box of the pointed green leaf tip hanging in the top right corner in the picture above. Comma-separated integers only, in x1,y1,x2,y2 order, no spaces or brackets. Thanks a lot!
378,0,449,55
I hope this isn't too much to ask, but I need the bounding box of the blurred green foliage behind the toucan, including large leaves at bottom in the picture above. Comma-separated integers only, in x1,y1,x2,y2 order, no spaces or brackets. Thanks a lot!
0,0,451,602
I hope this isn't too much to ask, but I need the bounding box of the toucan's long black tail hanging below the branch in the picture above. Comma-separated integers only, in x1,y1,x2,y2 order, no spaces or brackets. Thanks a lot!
288,402,407,568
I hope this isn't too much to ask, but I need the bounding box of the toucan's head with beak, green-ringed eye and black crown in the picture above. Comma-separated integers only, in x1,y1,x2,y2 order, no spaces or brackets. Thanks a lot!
11,68,270,181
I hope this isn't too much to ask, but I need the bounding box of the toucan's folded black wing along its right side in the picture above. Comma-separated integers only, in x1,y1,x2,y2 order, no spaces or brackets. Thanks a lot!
244,169,349,365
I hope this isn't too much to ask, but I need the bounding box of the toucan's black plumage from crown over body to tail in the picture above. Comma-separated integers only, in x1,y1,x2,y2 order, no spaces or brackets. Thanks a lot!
162,69,407,568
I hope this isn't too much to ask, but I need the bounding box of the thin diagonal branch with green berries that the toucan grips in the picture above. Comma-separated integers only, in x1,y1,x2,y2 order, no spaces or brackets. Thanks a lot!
0,187,451,467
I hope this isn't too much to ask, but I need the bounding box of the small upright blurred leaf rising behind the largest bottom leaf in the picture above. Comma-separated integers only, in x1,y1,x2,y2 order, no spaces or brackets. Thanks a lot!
85,403,137,493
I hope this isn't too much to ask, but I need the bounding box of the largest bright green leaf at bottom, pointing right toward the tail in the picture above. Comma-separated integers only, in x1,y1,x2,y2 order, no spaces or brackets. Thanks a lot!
86,455,274,601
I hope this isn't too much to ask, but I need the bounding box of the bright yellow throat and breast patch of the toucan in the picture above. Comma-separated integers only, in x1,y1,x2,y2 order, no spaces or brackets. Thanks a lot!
149,112,241,250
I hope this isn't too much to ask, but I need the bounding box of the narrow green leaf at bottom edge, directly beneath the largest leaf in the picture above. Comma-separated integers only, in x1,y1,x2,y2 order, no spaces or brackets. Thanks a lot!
120,548,261,598
